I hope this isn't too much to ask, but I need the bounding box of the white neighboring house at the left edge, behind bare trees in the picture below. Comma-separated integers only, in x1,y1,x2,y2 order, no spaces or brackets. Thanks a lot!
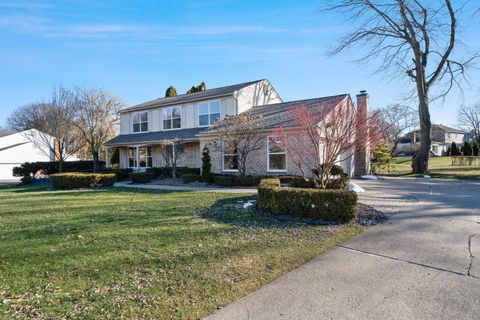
0,129,78,180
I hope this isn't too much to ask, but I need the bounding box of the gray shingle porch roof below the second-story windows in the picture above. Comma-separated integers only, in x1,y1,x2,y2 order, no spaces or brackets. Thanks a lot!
105,128,205,146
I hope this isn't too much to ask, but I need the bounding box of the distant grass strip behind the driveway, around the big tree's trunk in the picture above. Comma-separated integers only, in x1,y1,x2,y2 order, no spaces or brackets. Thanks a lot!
385,157,480,180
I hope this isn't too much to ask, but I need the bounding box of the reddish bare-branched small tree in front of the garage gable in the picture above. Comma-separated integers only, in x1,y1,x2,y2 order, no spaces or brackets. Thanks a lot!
272,100,384,189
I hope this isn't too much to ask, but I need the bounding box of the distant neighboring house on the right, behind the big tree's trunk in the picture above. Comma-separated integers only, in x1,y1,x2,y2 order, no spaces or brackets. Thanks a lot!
396,124,466,156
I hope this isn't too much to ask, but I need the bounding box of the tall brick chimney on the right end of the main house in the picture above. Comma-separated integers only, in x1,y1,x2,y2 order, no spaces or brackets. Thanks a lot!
354,90,370,177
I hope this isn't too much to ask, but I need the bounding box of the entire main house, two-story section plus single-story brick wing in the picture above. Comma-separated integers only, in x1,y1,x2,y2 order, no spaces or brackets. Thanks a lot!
106,80,368,175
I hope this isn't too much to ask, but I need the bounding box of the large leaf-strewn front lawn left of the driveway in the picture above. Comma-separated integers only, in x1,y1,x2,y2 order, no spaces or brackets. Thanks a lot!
0,187,363,319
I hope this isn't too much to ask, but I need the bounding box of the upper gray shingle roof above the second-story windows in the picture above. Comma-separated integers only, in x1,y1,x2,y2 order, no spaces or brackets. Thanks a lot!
120,79,264,113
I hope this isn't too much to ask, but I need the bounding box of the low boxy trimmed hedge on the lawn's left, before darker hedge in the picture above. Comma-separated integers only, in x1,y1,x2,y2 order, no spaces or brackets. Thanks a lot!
50,172,116,189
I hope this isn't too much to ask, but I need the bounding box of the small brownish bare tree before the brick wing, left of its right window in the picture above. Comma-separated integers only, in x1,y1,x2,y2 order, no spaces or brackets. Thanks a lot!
211,112,264,176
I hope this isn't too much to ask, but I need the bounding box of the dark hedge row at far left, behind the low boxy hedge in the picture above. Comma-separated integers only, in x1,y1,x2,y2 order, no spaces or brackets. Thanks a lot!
12,161,105,177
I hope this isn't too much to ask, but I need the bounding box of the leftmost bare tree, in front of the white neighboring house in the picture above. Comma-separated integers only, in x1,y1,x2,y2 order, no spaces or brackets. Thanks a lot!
7,87,82,172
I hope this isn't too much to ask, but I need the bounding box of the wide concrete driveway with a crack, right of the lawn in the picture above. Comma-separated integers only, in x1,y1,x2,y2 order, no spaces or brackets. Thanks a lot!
208,178,480,319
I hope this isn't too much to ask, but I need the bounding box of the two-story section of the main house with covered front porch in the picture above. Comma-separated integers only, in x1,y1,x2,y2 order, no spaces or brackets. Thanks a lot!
106,80,282,170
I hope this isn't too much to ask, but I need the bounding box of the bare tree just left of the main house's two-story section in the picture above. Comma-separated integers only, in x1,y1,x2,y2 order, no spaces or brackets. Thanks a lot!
75,88,123,172
